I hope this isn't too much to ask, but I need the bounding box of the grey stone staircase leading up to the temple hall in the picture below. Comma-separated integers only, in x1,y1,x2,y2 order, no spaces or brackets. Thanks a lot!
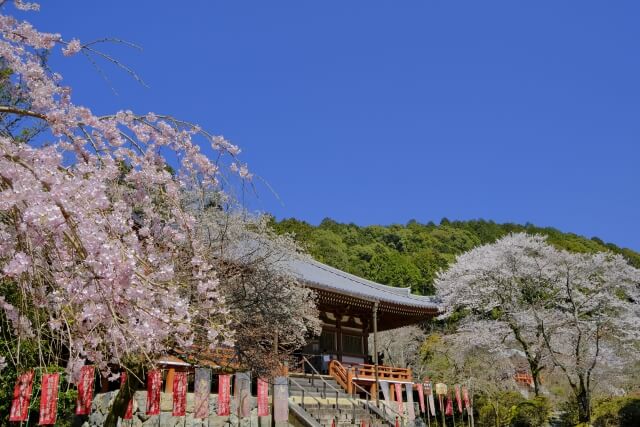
289,374,390,427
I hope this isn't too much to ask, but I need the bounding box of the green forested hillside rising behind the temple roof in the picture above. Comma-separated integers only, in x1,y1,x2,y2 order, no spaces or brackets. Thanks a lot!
272,218,640,295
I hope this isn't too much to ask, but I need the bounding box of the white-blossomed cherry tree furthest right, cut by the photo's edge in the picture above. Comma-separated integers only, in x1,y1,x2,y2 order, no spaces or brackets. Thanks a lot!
538,251,640,422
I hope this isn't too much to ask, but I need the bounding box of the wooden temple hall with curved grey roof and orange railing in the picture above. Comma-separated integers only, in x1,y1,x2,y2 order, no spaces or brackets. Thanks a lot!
287,259,440,393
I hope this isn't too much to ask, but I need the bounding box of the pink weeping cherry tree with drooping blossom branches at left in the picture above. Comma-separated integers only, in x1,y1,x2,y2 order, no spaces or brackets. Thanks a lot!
0,1,251,382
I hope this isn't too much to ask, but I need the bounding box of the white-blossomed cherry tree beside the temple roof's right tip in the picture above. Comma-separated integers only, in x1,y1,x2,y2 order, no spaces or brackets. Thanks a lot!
436,234,557,394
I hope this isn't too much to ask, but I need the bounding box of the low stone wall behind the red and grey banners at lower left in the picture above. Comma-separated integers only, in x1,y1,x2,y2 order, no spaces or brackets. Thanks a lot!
78,391,271,427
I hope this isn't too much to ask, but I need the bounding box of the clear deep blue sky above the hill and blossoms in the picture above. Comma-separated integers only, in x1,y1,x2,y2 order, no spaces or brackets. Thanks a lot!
22,0,640,249
